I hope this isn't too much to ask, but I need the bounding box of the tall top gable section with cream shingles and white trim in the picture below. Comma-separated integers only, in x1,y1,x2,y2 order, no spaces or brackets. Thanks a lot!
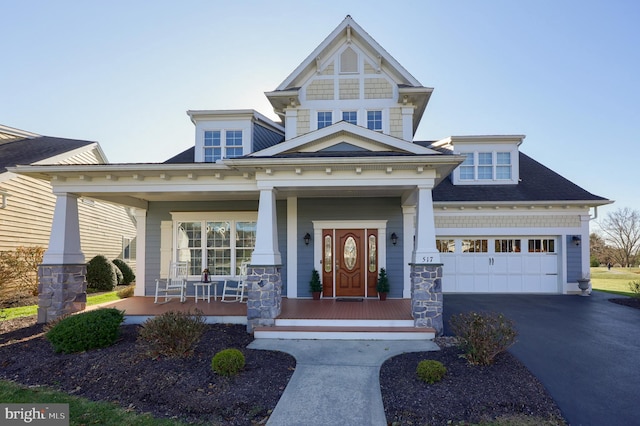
266,16,433,141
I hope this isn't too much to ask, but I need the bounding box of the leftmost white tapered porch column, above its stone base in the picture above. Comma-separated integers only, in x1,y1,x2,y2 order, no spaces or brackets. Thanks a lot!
42,192,85,265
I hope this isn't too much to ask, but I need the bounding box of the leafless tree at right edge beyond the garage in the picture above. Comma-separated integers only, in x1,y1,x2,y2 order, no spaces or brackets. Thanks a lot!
598,207,640,267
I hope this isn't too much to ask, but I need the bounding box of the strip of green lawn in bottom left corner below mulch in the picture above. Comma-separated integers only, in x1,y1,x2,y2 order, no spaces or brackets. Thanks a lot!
0,381,186,426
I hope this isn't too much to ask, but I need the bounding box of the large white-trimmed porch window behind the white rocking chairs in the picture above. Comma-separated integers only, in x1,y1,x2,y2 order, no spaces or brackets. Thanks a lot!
175,219,256,277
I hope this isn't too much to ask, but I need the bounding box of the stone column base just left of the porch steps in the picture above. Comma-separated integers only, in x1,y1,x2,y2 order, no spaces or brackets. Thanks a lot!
247,265,282,333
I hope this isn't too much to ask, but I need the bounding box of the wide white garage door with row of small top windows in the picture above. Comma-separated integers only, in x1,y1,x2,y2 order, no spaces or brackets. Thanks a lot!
436,237,560,293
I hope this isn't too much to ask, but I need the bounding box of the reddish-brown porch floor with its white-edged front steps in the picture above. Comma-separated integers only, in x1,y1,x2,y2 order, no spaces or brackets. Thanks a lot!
89,296,435,340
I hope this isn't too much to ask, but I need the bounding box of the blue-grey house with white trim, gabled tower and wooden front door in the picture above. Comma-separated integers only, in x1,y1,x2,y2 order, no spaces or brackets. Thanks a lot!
10,16,610,330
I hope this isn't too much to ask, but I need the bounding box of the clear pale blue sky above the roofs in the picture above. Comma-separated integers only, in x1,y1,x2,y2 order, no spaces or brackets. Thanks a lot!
0,0,640,220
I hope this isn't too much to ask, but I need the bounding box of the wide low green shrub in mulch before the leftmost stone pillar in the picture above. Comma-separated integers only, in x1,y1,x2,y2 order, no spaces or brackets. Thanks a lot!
45,308,124,354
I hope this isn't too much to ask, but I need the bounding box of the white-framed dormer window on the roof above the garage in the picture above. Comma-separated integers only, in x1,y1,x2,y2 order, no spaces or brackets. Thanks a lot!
459,152,512,181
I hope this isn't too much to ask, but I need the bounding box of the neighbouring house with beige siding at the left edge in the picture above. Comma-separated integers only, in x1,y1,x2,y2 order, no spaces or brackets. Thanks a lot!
0,125,136,294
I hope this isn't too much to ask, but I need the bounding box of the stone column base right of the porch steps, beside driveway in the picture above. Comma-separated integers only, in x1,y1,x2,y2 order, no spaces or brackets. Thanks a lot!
411,264,444,335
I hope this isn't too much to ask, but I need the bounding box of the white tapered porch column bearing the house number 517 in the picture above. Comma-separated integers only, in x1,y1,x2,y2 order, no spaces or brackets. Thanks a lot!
412,187,441,264
